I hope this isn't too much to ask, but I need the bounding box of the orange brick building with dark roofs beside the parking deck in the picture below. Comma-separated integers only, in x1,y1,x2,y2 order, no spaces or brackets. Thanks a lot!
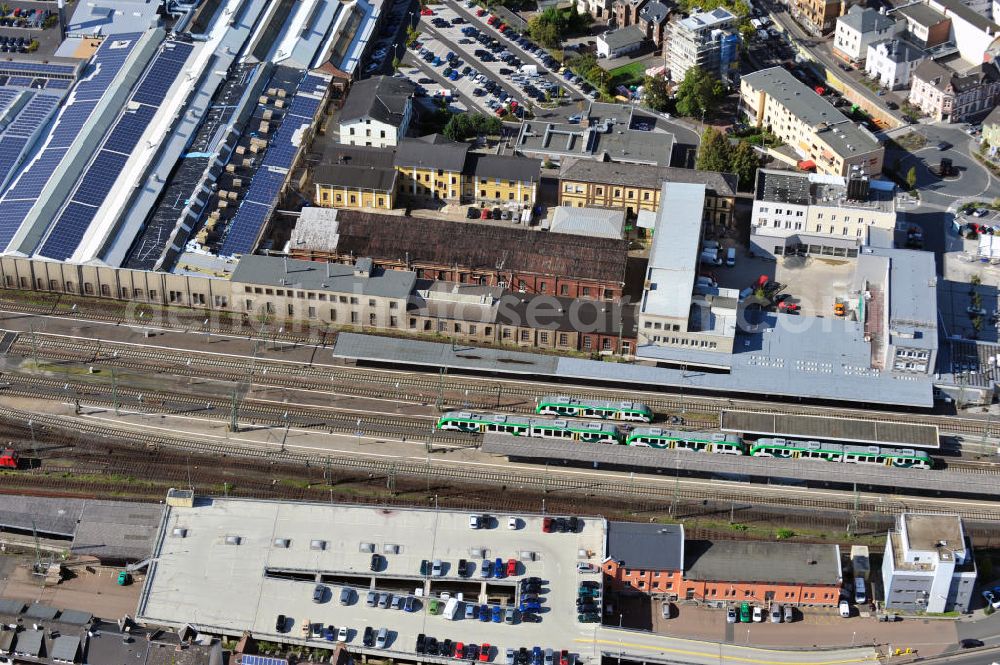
603,522,843,606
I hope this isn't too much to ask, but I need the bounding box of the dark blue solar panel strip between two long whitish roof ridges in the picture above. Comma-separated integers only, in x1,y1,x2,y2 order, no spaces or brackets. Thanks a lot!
38,42,193,261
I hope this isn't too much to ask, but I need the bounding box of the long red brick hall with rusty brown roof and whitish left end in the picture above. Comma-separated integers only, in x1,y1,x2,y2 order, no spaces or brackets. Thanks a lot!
288,209,628,301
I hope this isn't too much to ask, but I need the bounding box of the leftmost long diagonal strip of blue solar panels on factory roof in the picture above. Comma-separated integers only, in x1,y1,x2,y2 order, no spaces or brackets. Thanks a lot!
0,33,142,249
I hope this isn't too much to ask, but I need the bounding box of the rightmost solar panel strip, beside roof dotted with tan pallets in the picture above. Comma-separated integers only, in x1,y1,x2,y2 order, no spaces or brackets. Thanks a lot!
219,74,329,256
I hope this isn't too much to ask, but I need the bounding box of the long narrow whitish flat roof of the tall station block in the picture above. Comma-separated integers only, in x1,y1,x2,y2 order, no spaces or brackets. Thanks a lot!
641,182,705,319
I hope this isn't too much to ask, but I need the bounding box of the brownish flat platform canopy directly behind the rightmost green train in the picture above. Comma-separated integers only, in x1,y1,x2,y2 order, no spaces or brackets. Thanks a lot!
720,410,941,449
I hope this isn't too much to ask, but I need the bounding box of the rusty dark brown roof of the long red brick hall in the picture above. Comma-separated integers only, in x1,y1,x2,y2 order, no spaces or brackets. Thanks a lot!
326,210,628,282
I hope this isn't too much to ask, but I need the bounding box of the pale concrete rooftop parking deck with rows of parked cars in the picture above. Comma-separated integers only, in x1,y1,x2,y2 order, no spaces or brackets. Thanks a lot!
137,499,605,653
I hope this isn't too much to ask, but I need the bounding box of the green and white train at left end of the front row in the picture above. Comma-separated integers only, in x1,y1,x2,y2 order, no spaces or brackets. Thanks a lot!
437,411,622,443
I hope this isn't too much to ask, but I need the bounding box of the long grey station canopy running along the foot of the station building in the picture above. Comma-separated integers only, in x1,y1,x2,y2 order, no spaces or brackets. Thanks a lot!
332,332,934,408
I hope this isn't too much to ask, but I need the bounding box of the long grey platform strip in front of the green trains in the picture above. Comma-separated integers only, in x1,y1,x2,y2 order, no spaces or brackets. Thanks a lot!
482,432,1000,498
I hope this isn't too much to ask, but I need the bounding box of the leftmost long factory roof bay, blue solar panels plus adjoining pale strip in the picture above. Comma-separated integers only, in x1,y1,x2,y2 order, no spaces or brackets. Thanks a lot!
0,30,164,255
